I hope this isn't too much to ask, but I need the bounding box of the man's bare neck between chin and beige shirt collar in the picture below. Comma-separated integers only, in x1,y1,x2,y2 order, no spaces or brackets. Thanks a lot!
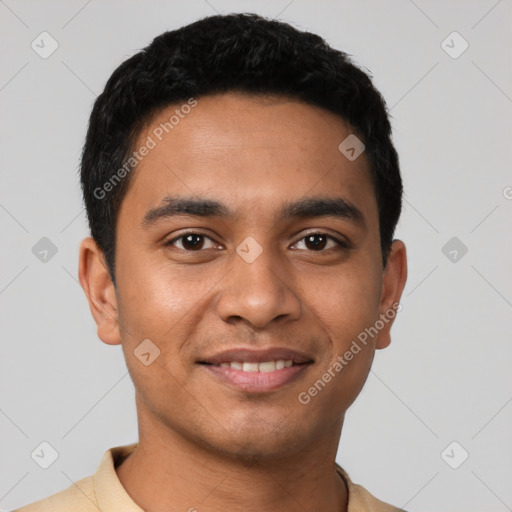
116,404,348,512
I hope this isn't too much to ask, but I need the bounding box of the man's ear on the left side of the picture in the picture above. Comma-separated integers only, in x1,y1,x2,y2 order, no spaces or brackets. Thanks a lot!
78,237,121,345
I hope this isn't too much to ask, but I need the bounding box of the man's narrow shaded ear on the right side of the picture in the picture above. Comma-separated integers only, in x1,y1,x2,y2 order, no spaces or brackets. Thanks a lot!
375,240,407,349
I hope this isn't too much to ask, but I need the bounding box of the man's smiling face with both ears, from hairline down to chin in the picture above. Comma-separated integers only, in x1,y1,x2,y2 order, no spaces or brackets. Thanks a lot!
80,93,405,457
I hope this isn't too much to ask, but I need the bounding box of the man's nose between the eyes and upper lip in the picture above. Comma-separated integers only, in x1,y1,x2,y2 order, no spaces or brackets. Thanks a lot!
217,243,301,329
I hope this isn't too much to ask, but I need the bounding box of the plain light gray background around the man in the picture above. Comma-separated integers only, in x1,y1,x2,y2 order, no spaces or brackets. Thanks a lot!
0,0,512,512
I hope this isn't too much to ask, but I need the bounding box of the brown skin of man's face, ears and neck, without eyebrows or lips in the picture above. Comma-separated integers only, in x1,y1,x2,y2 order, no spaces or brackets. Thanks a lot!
79,93,407,512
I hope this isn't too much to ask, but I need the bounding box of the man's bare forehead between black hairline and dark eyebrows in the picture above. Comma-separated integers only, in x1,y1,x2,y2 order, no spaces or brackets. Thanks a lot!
120,93,376,226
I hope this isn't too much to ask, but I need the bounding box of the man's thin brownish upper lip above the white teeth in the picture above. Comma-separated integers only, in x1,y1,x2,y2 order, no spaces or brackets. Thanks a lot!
198,347,313,364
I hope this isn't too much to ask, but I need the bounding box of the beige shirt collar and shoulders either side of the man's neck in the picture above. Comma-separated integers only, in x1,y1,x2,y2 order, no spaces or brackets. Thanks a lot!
13,443,400,512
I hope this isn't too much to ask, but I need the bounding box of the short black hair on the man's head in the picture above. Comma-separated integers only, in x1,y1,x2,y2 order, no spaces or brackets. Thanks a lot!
80,13,402,284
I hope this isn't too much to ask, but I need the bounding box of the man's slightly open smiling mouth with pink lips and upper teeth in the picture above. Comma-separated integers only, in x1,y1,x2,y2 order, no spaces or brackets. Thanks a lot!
198,349,314,393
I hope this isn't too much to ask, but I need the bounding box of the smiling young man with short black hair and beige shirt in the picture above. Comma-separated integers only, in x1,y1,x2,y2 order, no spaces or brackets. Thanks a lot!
20,14,406,512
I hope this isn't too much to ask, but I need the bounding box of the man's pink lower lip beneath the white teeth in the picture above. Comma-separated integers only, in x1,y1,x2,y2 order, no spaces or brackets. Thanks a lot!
201,364,309,393
